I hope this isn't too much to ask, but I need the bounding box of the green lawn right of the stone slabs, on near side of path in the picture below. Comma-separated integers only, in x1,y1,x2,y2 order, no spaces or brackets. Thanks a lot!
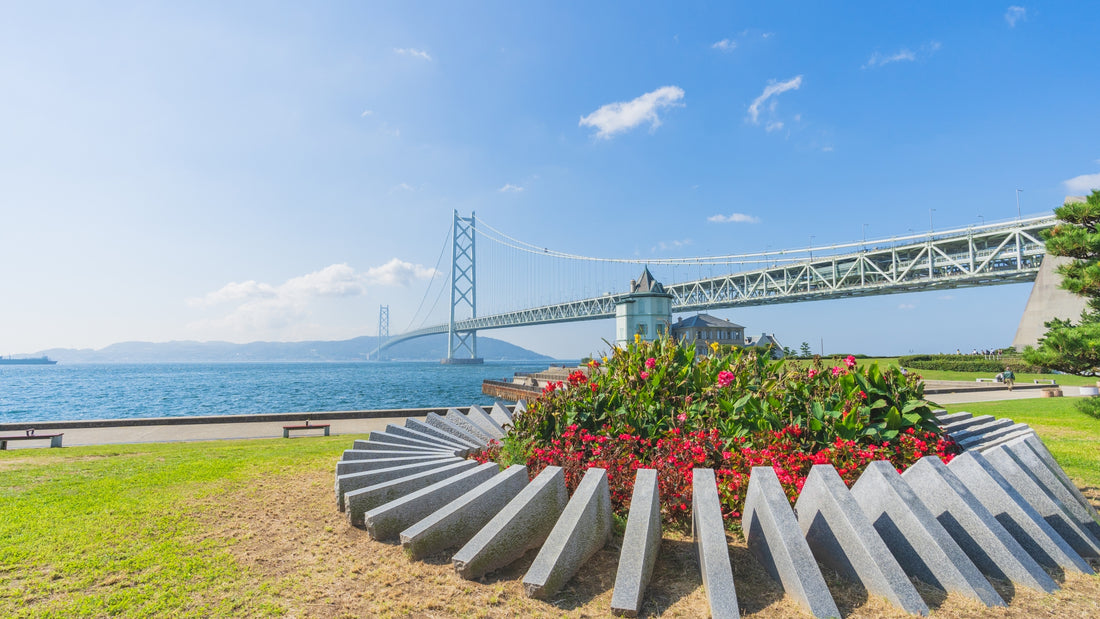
944,398,1100,488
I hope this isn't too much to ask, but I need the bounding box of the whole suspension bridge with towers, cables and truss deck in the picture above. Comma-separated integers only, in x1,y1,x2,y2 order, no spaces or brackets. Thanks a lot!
375,211,1056,363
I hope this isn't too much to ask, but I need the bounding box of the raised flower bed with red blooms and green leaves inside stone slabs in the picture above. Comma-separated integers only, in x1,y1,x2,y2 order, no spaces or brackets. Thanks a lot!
475,340,957,522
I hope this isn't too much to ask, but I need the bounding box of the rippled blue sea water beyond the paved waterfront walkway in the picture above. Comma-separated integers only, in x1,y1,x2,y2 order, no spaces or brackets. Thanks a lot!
0,362,548,423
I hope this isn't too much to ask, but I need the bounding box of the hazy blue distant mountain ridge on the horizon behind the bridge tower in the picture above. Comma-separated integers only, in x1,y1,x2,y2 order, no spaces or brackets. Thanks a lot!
35,335,551,363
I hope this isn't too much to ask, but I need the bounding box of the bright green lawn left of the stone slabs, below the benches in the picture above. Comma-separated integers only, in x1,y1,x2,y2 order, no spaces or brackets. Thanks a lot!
0,436,349,617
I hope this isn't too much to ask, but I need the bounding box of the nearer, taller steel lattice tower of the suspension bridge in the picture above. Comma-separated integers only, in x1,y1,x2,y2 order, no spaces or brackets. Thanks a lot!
442,211,483,364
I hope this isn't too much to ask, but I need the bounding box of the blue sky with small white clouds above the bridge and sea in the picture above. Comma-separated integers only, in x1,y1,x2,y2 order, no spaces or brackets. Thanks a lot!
0,2,1100,357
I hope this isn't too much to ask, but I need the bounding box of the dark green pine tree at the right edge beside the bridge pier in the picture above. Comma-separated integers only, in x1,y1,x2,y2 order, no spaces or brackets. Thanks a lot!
1024,190,1100,374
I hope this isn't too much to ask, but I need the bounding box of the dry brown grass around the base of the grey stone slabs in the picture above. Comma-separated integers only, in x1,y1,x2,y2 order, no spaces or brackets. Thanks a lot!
196,471,1100,619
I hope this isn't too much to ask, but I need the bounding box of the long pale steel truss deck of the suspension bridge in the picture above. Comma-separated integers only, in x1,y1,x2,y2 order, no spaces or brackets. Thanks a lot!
380,215,1057,350
